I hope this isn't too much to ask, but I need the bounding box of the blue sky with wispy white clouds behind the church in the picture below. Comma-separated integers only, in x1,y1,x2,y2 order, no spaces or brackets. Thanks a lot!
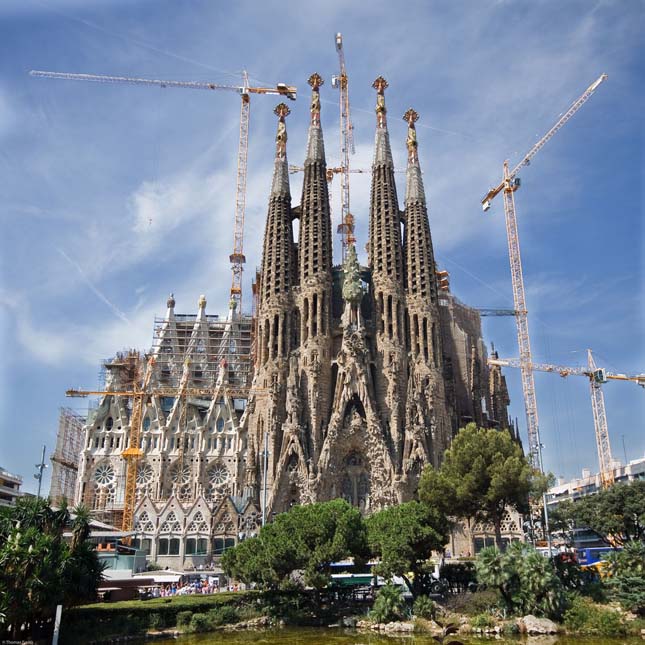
0,0,645,491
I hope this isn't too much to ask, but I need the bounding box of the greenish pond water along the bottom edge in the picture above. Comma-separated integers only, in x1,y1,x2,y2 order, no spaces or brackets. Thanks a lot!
154,627,643,645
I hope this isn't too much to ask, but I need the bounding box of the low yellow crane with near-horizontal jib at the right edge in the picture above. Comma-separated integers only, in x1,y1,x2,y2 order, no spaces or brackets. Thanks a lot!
488,349,645,488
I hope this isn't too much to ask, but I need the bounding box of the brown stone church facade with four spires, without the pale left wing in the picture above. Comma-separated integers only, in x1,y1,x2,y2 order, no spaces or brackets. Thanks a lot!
243,75,509,513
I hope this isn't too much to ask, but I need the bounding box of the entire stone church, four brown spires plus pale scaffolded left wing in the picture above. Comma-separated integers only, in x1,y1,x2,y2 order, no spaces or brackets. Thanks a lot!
70,74,514,568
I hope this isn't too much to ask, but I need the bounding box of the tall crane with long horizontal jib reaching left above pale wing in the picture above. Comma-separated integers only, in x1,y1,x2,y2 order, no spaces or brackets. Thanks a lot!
29,70,297,313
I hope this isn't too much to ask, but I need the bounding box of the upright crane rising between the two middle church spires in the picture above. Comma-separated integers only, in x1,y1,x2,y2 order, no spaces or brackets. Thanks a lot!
331,33,356,262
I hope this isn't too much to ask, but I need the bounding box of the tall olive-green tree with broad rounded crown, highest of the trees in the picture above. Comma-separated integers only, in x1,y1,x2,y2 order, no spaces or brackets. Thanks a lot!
419,423,545,548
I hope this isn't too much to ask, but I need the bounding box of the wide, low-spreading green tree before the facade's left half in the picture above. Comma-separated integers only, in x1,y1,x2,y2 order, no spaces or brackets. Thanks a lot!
222,499,367,589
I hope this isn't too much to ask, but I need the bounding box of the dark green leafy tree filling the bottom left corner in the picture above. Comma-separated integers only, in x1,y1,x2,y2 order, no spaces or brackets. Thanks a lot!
0,498,103,639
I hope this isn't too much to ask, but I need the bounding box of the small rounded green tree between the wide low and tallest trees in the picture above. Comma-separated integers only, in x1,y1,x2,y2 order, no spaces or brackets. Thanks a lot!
366,502,450,598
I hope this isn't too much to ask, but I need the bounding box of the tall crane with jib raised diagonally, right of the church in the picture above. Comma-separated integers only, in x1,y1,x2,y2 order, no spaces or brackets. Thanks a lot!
481,74,607,470
